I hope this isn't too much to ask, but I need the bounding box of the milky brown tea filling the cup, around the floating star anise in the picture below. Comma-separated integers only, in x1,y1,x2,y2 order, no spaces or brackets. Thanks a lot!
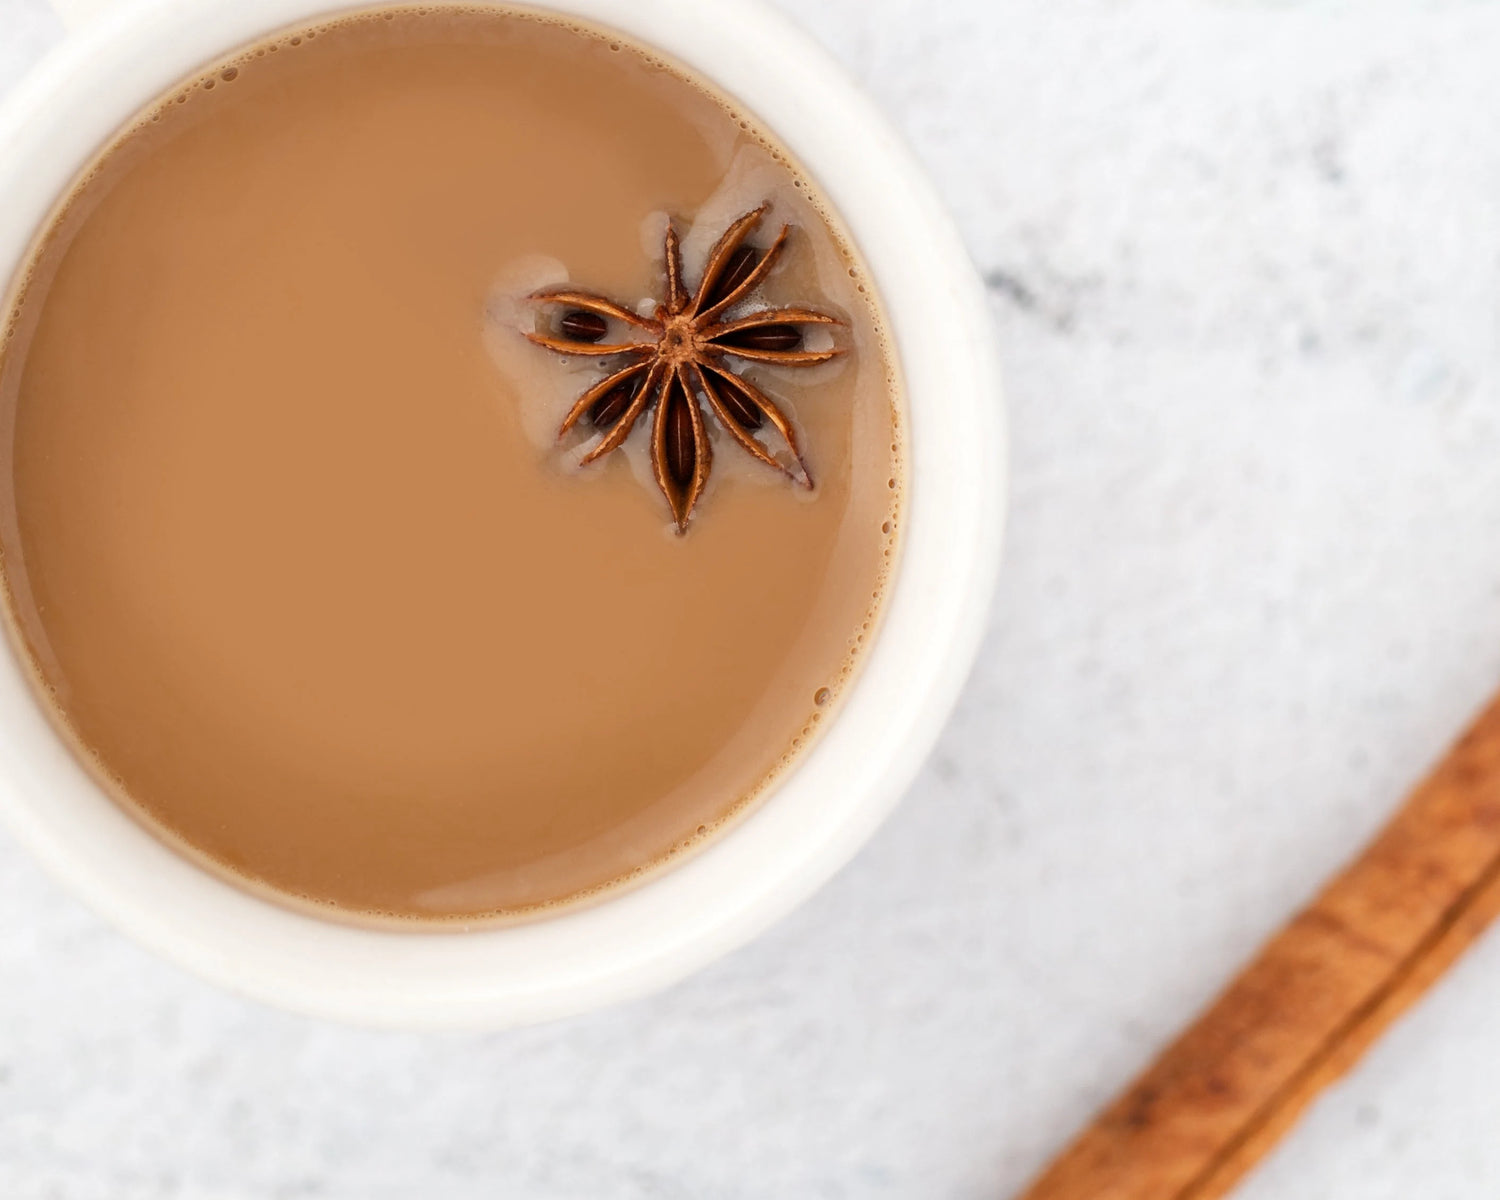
0,11,900,920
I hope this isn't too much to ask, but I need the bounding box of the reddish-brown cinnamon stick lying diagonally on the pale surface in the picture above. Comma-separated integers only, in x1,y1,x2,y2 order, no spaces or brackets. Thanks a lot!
1023,699,1500,1200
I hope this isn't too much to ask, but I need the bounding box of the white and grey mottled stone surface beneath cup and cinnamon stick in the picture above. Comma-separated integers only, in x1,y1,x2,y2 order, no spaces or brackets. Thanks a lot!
0,0,1500,1200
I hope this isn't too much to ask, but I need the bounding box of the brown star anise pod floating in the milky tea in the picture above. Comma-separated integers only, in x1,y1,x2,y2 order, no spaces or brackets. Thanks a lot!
527,204,843,533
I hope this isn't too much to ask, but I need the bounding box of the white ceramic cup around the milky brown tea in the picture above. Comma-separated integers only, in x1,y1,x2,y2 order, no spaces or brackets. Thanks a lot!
0,0,1005,1028
